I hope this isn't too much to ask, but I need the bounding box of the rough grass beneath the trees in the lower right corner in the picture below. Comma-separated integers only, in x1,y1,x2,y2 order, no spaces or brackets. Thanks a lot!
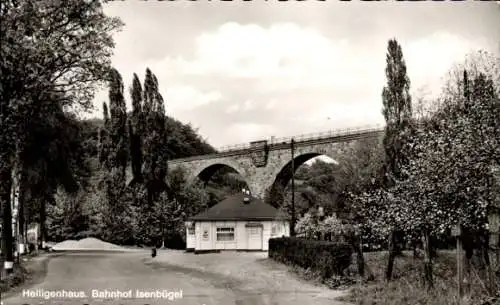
339,251,500,305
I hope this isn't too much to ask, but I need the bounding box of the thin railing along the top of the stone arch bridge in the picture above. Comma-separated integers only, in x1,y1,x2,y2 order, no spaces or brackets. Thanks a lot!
218,124,384,152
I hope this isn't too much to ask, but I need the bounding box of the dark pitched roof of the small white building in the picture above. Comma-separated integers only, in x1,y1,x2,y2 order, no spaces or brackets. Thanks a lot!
189,193,290,221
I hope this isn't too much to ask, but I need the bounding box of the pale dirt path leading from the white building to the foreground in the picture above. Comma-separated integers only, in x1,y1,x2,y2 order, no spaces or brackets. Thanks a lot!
145,251,352,305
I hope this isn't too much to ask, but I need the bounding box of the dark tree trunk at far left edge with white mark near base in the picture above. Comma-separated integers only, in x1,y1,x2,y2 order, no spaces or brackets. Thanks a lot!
0,164,14,273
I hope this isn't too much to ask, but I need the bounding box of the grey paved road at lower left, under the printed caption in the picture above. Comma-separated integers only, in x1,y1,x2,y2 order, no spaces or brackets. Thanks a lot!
2,252,350,305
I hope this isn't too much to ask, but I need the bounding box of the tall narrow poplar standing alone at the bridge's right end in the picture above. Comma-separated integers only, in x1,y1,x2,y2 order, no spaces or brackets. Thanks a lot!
382,39,412,280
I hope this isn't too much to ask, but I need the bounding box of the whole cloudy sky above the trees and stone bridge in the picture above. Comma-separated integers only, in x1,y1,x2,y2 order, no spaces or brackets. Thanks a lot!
91,1,500,147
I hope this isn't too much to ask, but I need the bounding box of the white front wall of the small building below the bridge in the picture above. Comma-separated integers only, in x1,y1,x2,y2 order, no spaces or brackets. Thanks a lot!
186,221,290,251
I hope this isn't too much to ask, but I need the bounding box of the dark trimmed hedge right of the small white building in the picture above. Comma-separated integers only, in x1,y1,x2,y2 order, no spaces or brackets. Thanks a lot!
269,237,352,279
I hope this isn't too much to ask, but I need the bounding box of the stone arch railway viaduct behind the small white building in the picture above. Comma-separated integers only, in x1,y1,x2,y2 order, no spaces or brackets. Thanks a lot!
168,126,384,198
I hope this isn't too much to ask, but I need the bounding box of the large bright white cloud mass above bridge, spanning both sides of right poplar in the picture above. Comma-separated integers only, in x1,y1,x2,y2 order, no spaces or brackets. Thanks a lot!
89,22,492,146
